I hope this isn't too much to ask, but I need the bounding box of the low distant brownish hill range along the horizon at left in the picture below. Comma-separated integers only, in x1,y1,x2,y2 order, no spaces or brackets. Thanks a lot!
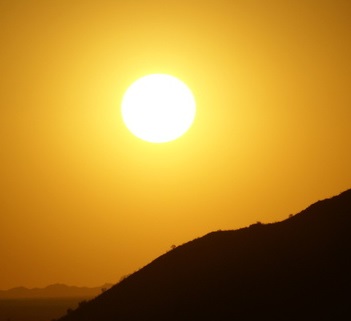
0,284,112,299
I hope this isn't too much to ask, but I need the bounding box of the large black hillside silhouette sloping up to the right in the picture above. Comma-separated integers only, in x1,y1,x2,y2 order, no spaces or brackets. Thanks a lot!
60,190,351,321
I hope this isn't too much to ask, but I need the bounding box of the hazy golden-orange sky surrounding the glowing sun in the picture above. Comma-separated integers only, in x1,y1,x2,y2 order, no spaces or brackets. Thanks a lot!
0,0,351,289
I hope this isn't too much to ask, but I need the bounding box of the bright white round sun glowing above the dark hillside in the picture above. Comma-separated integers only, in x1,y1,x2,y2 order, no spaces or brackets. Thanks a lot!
122,74,196,143
